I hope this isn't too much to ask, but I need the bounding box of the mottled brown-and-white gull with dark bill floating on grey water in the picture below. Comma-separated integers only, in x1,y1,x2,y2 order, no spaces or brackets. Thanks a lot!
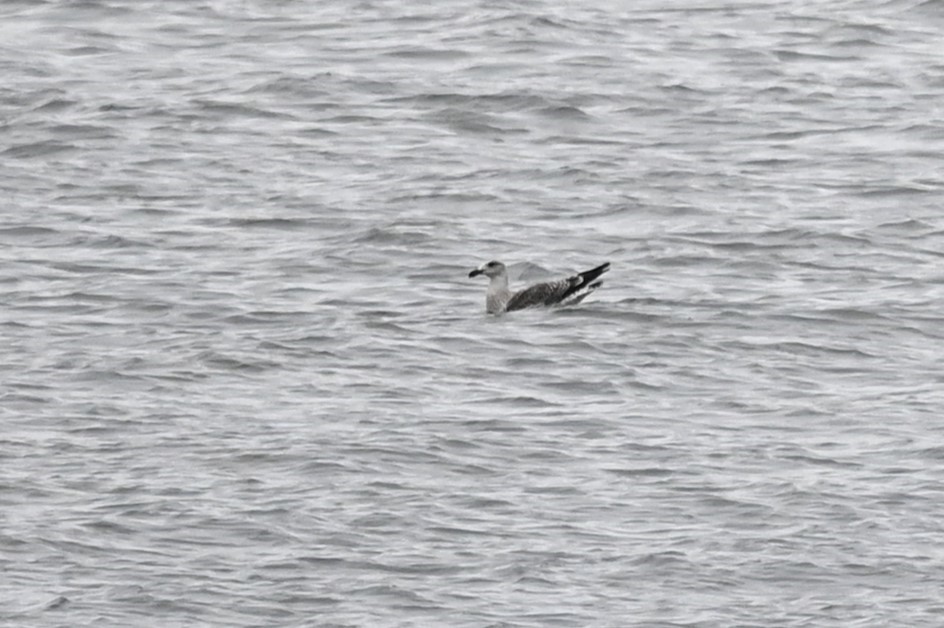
469,261,610,314
